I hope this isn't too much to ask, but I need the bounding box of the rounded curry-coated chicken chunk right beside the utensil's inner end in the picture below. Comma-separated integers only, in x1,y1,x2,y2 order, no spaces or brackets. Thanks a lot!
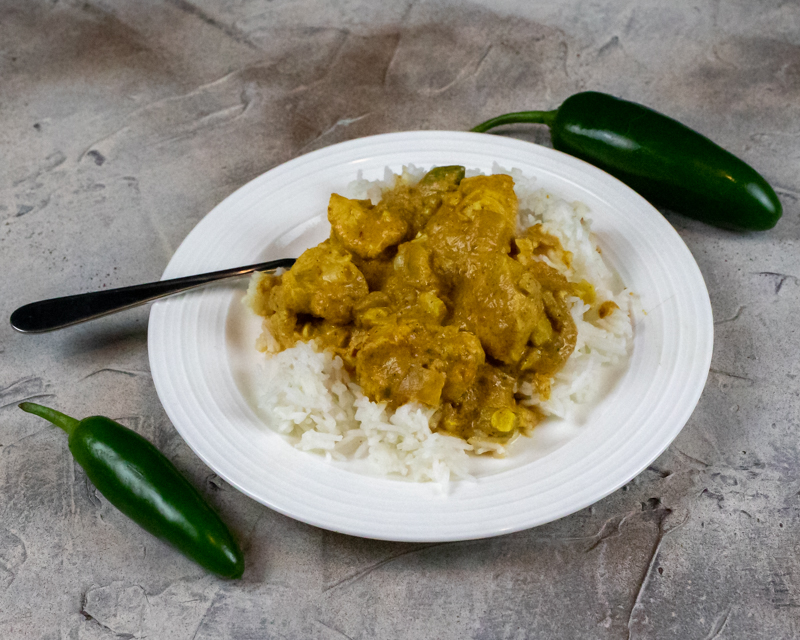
280,240,369,324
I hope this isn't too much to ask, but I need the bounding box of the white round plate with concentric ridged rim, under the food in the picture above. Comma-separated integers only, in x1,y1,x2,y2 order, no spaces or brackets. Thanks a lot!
148,131,713,541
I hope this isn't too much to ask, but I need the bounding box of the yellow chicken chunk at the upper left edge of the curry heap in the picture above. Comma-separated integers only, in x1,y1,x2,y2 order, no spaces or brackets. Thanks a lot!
328,193,408,258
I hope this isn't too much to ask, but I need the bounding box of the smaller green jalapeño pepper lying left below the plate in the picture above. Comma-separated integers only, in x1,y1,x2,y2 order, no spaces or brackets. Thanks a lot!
19,402,244,578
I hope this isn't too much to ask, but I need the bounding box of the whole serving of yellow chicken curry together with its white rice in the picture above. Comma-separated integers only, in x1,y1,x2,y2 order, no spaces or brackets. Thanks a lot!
245,166,631,480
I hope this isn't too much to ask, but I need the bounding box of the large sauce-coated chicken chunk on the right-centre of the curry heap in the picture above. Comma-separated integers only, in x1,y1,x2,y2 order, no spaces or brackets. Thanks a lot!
451,253,544,364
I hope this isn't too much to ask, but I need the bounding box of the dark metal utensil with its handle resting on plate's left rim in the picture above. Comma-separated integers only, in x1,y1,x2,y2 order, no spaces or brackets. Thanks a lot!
11,258,295,333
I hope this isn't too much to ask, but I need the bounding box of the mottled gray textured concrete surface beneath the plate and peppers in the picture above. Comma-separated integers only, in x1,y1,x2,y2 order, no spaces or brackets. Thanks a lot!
0,0,800,640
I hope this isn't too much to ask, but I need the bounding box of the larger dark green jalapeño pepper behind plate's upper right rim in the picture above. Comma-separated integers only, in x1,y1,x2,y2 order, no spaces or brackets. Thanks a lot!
472,91,782,231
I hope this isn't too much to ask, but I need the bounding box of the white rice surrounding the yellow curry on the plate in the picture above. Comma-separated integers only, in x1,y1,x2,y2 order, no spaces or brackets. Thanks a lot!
244,164,633,484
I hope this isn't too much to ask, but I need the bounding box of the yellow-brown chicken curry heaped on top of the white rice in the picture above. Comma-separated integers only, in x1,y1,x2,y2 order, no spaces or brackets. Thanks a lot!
253,166,616,450
